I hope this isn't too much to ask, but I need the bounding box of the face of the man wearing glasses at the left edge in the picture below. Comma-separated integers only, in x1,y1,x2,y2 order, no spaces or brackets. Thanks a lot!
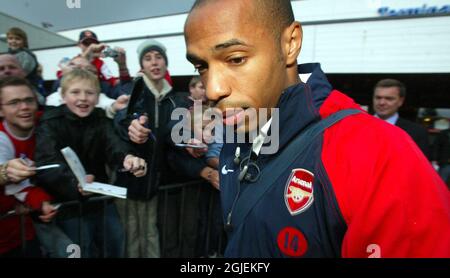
0,85,38,134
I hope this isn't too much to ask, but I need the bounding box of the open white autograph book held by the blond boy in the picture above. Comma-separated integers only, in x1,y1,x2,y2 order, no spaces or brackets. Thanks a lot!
61,147,127,199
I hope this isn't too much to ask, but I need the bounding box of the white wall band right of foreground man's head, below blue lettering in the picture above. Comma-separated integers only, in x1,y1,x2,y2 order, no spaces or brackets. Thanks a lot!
299,16,450,73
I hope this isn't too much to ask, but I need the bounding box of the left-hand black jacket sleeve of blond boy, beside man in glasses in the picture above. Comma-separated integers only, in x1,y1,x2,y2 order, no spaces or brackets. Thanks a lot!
34,121,81,201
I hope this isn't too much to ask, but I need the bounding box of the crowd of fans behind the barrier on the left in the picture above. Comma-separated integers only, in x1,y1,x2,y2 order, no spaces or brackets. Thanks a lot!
0,28,223,257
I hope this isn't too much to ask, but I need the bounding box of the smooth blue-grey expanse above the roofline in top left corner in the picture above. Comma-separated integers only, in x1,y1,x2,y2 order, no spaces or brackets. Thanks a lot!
0,0,194,32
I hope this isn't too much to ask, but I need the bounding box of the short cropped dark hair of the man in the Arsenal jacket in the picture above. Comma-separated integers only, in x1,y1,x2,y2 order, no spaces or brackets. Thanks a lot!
190,0,295,40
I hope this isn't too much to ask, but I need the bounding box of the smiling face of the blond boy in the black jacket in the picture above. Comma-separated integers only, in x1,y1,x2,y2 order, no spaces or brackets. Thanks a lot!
63,79,99,118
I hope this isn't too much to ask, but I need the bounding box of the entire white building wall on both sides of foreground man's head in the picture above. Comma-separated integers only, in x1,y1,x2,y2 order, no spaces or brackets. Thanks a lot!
36,0,450,79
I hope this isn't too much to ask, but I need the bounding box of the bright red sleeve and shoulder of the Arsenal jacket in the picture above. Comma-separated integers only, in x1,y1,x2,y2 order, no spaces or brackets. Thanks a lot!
322,115,450,258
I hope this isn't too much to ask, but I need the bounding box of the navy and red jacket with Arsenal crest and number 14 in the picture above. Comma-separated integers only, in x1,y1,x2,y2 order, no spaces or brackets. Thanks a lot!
220,64,450,258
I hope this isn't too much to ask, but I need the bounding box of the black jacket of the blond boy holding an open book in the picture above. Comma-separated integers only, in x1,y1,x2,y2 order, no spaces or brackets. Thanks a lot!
35,105,130,217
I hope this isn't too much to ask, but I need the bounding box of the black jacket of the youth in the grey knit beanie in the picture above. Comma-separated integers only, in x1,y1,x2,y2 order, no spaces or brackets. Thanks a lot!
114,78,206,200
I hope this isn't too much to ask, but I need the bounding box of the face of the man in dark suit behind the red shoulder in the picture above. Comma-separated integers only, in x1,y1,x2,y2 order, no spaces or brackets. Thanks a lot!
373,87,404,119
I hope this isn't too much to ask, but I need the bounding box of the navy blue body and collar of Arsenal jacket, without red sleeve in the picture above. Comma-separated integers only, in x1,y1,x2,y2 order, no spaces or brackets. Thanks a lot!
220,64,346,257
